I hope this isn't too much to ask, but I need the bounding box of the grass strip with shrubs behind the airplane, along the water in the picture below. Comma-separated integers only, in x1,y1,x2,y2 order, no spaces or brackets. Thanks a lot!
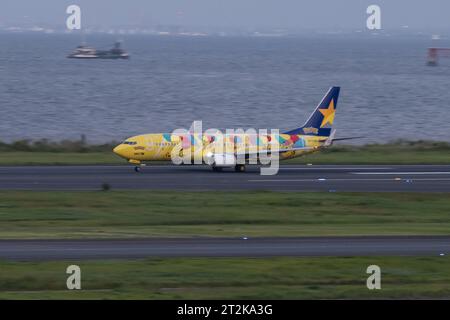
0,141,450,165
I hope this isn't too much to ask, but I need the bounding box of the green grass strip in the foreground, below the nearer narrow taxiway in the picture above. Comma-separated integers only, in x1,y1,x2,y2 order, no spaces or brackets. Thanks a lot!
0,257,450,299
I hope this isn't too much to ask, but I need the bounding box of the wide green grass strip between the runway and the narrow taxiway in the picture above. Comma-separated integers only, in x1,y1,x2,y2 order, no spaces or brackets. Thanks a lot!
0,191,450,239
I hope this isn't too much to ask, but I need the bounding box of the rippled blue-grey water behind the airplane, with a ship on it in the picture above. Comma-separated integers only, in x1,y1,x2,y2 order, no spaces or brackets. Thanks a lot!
0,34,450,142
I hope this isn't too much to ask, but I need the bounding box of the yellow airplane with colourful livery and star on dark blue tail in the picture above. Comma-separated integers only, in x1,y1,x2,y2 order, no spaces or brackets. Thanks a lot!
113,87,342,172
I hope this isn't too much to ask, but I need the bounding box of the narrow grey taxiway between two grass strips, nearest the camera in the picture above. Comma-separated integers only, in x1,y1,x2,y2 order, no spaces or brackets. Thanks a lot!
0,236,450,260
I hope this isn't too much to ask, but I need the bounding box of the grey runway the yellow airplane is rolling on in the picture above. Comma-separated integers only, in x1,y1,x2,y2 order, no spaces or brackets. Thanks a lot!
0,164,450,192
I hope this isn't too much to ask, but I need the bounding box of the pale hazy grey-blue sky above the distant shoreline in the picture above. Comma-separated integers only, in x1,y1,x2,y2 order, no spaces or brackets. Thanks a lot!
0,0,450,30
